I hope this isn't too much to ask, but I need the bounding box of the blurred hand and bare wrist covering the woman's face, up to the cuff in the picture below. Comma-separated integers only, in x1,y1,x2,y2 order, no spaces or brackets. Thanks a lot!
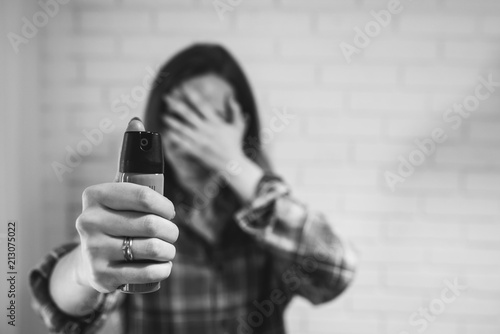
164,87,264,202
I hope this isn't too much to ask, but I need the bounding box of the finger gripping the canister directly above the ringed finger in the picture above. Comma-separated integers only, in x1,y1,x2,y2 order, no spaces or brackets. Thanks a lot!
92,210,179,243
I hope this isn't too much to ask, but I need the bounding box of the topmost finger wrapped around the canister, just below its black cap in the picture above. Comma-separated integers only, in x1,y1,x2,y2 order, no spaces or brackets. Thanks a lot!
86,182,175,220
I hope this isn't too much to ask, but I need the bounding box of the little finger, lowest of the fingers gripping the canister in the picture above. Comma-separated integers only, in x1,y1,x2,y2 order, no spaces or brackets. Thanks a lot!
108,261,172,287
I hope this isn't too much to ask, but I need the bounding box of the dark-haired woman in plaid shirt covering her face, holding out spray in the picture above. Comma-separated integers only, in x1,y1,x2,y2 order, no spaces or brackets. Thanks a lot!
30,45,354,334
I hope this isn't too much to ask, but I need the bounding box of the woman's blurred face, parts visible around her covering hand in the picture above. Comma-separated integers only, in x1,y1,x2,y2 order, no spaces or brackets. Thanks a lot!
162,74,234,189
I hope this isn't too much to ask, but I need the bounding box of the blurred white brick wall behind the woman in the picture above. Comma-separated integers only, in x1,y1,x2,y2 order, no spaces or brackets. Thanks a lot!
0,0,500,334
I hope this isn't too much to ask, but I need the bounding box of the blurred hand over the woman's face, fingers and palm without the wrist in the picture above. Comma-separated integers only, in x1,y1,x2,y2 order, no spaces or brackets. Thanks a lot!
164,87,246,171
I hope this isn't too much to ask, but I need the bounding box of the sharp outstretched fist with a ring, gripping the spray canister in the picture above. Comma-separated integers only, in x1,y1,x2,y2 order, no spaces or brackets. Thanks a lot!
75,183,179,293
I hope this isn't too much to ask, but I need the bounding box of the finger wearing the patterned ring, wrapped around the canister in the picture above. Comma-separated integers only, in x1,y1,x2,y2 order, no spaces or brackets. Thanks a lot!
107,238,175,262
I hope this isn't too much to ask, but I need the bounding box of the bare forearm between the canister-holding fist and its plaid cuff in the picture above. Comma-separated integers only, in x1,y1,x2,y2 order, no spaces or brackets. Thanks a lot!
49,246,102,317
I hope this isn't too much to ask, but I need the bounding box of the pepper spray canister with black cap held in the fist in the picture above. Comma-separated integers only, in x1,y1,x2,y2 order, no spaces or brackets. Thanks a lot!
118,118,164,293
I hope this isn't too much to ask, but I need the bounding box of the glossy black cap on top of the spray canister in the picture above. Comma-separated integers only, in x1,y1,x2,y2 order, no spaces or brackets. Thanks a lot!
120,131,164,174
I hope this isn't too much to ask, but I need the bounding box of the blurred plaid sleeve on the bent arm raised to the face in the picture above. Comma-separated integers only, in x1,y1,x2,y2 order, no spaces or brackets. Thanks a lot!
236,175,357,304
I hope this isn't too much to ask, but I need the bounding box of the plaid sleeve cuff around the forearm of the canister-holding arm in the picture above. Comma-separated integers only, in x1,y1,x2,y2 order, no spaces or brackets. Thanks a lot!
29,242,123,334
